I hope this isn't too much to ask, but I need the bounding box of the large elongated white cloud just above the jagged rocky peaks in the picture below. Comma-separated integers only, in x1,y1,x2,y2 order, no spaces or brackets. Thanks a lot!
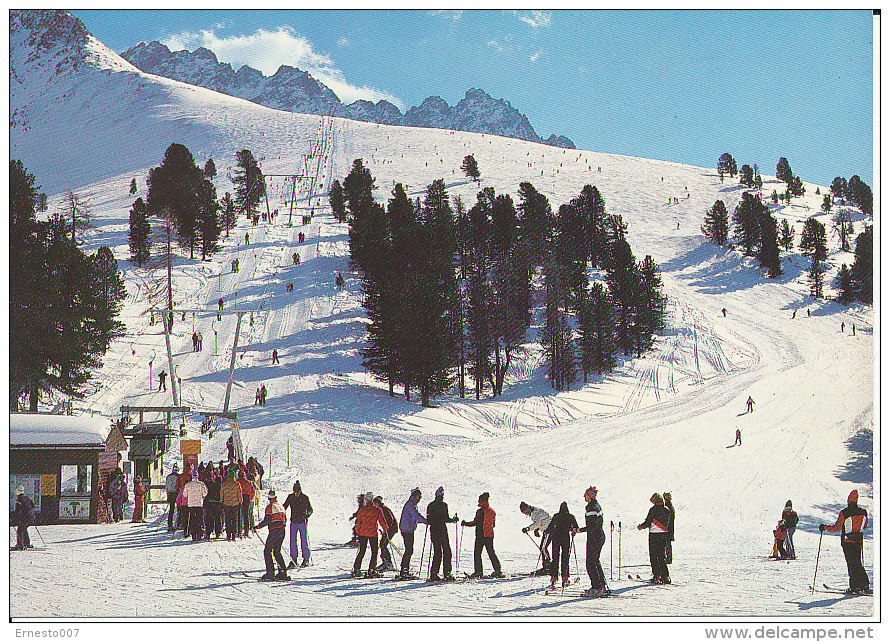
164,27,403,109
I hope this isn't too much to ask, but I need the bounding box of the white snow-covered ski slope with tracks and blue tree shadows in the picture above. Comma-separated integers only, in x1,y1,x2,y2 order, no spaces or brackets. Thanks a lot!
10,11,880,619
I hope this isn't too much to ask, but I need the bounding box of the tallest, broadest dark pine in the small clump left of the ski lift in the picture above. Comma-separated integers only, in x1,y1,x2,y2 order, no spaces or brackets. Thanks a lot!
147,143,204,258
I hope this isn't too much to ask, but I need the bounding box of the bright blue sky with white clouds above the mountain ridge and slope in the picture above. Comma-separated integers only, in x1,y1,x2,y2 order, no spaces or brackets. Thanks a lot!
73,10,874,185
